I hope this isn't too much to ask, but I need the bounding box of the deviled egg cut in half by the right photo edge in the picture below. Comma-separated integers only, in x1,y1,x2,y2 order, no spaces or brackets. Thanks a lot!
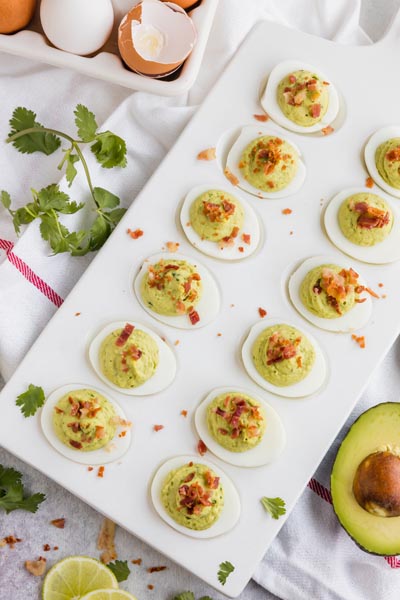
364,125,400,198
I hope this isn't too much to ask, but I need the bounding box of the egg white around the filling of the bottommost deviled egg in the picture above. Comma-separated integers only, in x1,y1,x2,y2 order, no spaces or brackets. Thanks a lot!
150,455,241,539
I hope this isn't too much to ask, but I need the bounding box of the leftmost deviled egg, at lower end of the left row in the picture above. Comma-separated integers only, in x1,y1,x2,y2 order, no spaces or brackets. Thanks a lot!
40,384,132,465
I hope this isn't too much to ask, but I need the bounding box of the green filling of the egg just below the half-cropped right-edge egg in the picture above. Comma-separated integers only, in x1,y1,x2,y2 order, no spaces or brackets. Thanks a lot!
338,193,393,246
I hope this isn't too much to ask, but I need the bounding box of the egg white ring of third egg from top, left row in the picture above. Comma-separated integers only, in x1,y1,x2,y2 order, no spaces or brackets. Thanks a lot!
180,183,262,260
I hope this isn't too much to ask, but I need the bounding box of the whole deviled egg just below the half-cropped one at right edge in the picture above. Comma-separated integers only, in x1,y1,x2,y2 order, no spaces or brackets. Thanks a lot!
324,188,400,264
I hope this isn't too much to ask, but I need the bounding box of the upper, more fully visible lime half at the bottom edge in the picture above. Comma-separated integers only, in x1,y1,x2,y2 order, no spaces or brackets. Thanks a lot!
42,556,118,600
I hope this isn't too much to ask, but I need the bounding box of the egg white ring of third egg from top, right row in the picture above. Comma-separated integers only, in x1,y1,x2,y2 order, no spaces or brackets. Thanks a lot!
288,256,372,332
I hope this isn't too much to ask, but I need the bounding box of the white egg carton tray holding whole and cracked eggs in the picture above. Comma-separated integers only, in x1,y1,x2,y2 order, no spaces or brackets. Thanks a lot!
0,0,219,96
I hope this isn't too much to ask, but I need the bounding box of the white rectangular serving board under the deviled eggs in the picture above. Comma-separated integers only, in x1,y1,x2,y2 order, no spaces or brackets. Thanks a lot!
0,17,400,597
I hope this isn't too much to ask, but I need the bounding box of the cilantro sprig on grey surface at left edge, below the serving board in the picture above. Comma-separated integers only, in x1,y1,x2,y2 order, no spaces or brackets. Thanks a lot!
0,465,46,514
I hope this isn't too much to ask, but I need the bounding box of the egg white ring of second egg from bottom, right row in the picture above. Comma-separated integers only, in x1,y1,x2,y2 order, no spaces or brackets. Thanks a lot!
194,386,286,467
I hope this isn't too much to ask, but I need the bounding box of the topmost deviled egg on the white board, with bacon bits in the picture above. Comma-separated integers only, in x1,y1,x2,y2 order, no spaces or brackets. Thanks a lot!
261,60,340,133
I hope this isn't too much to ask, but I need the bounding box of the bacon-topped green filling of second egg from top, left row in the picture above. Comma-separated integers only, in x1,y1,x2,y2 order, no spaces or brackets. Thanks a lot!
239,135,299,192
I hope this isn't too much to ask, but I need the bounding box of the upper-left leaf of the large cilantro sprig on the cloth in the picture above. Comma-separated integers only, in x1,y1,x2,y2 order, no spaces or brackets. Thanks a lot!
8,106,61,156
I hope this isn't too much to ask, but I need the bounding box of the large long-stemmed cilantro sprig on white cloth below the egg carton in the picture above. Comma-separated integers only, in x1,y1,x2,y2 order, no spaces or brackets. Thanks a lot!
0,104,127,256
